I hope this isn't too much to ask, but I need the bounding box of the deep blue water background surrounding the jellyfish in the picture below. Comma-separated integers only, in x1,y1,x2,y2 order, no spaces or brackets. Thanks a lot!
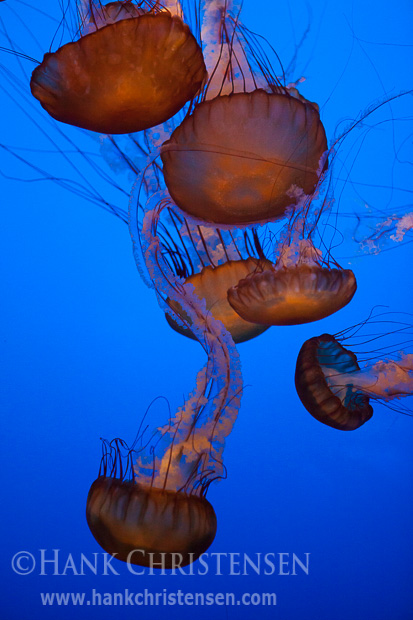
0,0,413,620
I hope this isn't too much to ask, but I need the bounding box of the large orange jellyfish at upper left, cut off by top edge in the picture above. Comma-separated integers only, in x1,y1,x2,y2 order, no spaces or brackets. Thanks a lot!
30,0,206,134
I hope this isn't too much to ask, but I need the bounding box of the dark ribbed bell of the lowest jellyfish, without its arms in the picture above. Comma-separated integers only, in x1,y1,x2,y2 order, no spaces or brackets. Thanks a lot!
86,476,217,568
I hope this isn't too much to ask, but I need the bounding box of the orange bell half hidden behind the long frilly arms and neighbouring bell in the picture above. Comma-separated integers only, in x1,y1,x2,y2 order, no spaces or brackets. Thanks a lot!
166,258,269,344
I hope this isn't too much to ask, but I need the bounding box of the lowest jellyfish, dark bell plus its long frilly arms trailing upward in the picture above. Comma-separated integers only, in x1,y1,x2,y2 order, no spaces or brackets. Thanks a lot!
86,196,242,568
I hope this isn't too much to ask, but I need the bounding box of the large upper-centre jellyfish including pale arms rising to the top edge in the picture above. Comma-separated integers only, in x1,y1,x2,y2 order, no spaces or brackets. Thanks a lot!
161,3,327,225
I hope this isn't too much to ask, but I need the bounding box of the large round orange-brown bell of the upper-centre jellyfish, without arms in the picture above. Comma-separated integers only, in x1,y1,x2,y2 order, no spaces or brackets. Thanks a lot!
161,89,327,225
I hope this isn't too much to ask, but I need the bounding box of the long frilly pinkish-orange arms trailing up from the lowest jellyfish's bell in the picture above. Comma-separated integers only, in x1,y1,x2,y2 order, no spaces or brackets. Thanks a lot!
131,196,242,490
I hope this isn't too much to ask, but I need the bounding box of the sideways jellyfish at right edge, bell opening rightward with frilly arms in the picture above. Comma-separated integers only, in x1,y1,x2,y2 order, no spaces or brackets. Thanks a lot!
295,334,413,431
